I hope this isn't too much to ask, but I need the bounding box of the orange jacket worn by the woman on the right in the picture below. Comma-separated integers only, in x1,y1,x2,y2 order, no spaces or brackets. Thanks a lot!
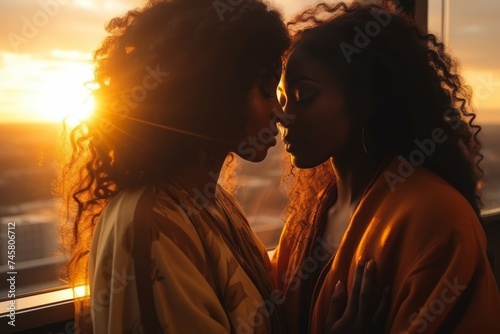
273,158,500,334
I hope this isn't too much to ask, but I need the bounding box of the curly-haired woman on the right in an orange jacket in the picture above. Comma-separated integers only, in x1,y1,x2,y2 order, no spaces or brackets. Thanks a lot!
273,3,500,333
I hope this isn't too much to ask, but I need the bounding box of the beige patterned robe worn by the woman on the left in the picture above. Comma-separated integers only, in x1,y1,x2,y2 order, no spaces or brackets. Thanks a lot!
89,184,282,334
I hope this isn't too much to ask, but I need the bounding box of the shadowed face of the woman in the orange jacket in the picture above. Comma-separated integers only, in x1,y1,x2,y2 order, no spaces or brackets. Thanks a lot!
278,48,350,168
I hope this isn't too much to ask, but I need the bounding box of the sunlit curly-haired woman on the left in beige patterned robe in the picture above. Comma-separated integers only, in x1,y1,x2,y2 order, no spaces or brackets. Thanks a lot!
60,0,386,333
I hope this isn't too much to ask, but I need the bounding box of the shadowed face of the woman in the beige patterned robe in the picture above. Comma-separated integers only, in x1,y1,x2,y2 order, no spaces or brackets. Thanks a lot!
234,76,281,162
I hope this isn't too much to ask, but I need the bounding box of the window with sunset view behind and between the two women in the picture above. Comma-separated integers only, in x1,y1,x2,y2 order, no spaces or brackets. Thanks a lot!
0,0,500,332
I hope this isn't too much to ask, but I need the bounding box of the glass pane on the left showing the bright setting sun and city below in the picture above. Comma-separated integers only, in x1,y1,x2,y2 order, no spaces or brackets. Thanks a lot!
0,0,142,299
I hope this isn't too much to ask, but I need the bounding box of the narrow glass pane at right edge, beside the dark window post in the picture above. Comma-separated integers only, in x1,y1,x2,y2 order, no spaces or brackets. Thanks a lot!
449,0,500,209
